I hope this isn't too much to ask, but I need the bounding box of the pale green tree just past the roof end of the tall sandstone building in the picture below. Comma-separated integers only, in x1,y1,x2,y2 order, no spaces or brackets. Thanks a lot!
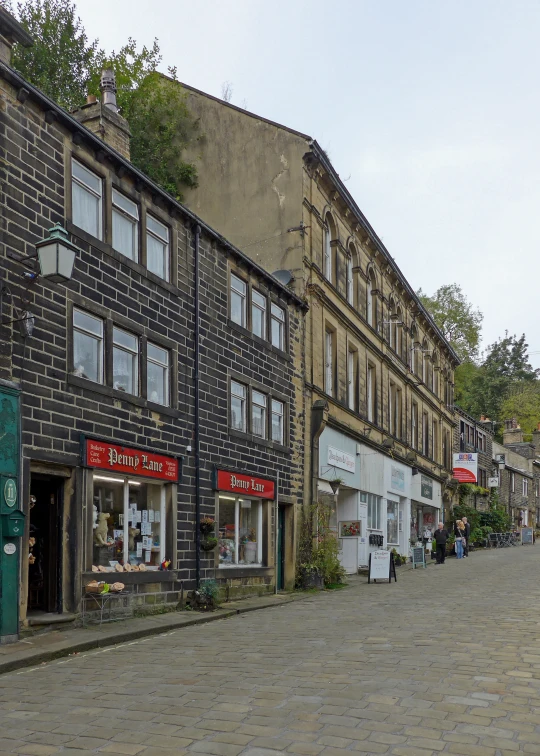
417,284,484,362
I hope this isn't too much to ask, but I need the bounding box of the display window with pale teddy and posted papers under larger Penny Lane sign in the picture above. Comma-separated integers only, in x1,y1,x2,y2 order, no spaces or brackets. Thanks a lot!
92,475,165,569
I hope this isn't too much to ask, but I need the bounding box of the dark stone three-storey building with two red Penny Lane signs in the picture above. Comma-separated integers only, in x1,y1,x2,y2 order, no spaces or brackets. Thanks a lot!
0,9,304,639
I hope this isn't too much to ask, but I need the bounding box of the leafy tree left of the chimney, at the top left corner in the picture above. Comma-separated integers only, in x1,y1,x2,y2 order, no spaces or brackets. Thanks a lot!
1,0,100,110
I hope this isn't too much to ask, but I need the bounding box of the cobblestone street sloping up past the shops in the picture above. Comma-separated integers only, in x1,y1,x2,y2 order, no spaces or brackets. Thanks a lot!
0,547,540,756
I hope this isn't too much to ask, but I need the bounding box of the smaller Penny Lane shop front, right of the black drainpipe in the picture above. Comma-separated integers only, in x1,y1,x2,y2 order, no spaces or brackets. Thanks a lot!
213,467,278,596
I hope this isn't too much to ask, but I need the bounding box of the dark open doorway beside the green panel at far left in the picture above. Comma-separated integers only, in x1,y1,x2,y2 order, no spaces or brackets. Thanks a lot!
28,473,64,612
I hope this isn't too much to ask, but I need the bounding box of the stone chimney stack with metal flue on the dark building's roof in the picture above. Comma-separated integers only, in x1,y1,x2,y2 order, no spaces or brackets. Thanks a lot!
73,68,131,160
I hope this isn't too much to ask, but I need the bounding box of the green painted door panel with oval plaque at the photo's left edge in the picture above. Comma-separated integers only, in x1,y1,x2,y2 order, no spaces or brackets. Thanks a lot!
0,386,22,643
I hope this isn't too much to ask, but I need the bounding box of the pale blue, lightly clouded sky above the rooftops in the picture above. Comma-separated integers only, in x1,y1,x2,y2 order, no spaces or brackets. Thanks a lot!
76,0,540,367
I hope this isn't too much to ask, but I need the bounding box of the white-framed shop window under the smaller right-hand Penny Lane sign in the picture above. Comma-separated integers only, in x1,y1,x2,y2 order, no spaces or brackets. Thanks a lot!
218,495,266,567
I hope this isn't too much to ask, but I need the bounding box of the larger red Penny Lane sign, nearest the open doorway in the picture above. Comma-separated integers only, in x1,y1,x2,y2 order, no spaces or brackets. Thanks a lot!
85,438,178,482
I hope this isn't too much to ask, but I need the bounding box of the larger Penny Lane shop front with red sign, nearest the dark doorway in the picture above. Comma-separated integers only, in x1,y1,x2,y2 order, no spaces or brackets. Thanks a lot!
81,438,181,615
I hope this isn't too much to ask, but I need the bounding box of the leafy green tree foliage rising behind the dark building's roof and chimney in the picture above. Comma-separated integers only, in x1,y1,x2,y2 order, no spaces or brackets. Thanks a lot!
4,0,199,200
